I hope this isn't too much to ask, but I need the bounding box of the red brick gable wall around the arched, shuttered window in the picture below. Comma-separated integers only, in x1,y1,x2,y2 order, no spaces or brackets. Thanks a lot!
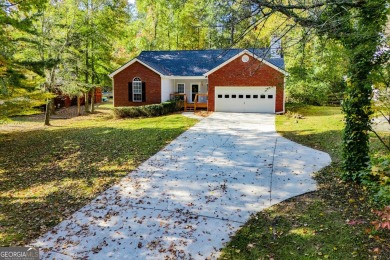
113,61,161,107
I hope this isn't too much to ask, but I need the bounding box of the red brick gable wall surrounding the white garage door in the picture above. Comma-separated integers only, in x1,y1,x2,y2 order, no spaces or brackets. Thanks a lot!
208,56,284,112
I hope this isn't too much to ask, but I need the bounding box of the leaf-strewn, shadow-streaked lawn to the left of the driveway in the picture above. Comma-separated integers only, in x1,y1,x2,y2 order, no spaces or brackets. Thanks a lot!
0,103,196,246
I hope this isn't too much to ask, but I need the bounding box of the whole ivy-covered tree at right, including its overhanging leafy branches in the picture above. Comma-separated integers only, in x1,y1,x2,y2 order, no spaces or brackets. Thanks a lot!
241,0,389,182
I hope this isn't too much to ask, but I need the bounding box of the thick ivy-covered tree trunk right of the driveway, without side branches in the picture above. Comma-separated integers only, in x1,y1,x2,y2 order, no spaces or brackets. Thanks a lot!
341,1,386,182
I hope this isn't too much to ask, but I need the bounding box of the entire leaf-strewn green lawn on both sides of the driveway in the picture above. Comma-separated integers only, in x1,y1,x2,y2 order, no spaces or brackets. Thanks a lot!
0,104,390,259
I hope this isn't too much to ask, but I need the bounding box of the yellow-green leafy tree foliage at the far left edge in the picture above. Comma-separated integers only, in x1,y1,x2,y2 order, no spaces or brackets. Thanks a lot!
0,0,48,117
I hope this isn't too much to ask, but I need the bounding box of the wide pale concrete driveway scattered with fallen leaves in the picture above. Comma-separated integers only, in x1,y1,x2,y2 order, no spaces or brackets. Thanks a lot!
33,113,331,259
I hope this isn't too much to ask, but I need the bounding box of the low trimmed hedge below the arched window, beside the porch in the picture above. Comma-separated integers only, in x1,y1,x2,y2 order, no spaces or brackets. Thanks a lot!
113,101,178,118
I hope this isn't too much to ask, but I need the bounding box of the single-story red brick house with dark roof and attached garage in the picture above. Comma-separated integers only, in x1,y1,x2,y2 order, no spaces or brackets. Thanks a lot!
110,37,287,113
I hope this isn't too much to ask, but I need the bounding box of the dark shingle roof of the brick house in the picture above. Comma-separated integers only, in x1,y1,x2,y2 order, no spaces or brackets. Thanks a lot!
111,49,284,76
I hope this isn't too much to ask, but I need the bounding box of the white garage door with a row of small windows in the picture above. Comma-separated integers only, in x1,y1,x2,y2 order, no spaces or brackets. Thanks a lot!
215,87,276,113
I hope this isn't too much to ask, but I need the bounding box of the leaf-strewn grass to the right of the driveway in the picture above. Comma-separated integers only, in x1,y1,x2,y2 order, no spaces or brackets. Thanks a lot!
221,106,390,259
